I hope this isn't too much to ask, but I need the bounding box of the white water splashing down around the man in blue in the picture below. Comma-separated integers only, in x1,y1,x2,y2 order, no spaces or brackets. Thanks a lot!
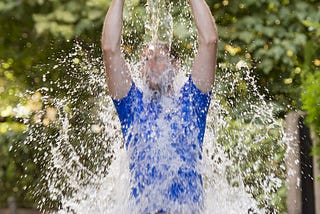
26,0,285,214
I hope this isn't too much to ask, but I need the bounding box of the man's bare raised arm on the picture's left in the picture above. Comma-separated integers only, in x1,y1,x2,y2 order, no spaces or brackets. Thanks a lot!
101,0,132,100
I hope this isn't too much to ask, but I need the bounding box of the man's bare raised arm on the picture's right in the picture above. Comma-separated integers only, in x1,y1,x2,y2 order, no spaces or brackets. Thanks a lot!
189,0,218,93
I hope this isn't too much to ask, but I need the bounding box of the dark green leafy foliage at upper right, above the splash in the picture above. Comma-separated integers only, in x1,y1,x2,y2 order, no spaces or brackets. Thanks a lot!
208,0,320,113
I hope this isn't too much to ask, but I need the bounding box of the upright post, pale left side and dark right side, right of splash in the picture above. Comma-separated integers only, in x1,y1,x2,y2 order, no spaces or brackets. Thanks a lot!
286,112,320,214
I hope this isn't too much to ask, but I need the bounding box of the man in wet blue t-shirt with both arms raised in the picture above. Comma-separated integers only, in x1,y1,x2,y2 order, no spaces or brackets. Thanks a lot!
102,0,218,213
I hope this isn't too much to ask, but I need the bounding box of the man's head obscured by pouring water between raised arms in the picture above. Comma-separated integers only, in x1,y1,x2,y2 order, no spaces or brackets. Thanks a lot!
142,44,178,94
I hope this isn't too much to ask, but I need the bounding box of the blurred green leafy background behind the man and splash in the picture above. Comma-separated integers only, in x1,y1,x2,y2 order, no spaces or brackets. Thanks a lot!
0,0,320,212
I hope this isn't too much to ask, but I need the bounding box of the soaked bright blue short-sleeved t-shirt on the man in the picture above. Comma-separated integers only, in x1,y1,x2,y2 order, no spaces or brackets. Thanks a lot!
114,77,211,213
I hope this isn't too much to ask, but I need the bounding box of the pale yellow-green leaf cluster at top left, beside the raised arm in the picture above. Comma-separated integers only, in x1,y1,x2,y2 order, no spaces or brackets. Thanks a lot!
33,0,108,39
